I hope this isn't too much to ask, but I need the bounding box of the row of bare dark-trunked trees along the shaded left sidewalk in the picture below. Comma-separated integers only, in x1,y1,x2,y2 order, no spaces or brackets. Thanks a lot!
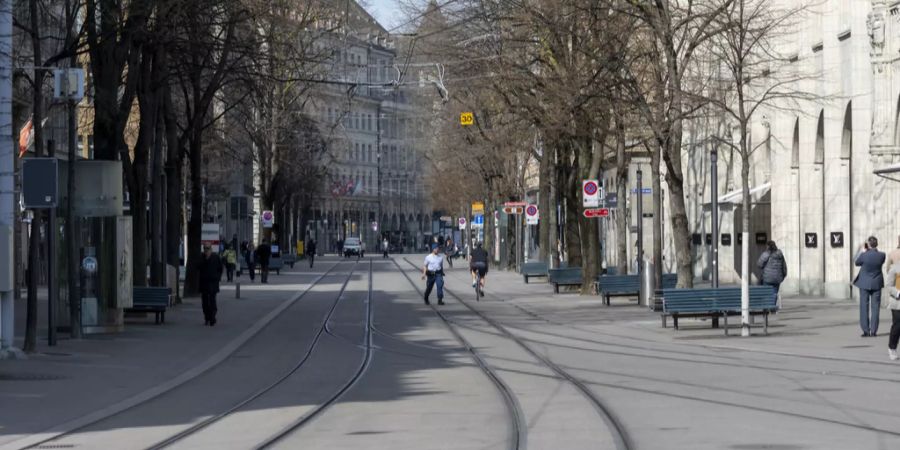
14,0,340,351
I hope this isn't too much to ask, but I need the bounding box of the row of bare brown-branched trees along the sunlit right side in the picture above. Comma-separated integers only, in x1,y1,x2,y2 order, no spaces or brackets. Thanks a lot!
418,0,811,316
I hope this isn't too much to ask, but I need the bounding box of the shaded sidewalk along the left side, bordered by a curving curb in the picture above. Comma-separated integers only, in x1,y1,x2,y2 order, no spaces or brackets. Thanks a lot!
0,261,332,446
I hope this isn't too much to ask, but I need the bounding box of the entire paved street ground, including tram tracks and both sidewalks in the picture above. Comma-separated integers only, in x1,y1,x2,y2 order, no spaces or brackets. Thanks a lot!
0,255,900,449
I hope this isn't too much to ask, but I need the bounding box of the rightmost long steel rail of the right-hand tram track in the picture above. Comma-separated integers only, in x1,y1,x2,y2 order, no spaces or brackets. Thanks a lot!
401,258,634,450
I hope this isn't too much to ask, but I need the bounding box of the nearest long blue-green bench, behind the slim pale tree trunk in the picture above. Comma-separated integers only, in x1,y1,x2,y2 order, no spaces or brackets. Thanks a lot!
662,286,778,335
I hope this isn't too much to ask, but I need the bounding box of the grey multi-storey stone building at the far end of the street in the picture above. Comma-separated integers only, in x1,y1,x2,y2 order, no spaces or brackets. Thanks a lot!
307,2,431,251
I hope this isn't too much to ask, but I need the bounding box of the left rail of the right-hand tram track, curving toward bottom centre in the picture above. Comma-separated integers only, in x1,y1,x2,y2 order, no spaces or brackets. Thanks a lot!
391,259,528,450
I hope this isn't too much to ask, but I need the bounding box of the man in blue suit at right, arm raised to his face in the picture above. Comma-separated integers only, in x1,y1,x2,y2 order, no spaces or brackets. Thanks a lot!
853,236,885,337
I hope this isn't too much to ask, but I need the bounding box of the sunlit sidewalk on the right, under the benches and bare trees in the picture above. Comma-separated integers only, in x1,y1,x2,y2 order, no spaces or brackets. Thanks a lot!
434,269,900,367
